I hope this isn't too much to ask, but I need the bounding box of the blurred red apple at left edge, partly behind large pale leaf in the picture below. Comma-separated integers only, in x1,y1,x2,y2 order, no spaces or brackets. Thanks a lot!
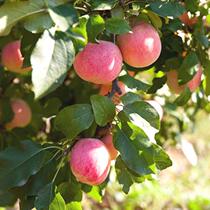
1,40,31,73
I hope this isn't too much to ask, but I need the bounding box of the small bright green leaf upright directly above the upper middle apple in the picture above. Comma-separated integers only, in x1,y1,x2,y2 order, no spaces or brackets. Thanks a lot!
87,15,105,42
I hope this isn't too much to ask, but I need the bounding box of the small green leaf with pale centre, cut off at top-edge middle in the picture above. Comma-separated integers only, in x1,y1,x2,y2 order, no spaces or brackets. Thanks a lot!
90,0,117,10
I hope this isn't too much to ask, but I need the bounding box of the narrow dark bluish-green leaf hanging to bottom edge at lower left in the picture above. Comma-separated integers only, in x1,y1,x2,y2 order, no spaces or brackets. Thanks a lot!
34,183,55,210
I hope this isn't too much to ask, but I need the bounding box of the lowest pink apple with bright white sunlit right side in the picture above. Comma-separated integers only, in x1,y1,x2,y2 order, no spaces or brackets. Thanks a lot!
70,138,111,185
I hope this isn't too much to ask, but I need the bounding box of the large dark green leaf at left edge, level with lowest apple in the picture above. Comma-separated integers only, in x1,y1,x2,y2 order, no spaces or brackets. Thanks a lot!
0,140,48,190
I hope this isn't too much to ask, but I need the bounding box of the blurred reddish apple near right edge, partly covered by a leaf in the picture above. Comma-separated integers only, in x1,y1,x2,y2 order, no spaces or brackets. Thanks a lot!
166,65,203,94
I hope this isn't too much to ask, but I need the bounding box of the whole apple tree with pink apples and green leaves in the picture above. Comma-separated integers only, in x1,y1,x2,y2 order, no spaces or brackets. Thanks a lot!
0,0,210,210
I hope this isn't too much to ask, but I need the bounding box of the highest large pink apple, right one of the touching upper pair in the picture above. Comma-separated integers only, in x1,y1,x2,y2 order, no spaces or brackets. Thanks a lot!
117,22,161,67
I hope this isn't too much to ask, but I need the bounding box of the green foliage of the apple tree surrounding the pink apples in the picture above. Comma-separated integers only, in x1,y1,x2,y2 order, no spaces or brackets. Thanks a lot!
0,0,210,210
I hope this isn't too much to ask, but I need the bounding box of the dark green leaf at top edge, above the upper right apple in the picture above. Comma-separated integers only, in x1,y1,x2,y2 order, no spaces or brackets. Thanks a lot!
150,1,185,18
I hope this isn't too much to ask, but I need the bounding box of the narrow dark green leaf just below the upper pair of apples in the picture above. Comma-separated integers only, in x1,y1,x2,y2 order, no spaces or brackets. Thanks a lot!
119,74,151,92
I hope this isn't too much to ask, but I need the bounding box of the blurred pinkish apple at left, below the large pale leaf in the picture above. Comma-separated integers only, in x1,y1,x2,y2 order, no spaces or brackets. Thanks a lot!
5,99,32,129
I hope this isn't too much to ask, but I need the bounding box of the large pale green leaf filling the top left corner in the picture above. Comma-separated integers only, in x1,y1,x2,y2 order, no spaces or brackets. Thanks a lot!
0,0,45,36
